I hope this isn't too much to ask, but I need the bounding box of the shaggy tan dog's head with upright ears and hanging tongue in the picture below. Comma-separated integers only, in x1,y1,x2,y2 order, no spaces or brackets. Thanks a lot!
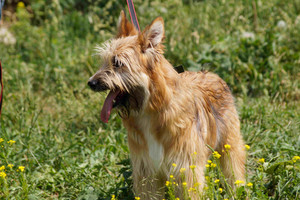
88,11,164,122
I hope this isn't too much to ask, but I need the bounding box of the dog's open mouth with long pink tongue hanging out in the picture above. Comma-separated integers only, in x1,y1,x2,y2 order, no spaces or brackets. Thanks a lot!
101,89,126,123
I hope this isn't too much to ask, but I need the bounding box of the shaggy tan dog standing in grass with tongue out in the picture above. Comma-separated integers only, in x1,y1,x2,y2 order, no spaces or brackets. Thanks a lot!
88,11,245,199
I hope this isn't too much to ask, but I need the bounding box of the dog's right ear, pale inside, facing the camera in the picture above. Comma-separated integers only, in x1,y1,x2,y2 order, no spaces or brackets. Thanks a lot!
139,17,165,51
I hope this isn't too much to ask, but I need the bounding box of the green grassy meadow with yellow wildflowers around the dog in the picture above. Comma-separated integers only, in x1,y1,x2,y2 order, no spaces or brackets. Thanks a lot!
0,0,300,200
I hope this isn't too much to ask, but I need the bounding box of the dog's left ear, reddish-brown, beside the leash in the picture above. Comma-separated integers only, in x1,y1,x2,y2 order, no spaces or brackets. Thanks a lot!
116,10,138,38
